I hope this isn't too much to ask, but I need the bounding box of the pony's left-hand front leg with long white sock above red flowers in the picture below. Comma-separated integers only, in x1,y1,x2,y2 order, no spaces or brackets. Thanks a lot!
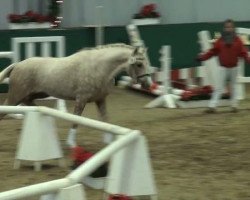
66,100,87,148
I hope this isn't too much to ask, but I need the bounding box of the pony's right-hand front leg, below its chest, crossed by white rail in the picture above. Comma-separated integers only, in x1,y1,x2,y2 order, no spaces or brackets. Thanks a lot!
95,98,114,144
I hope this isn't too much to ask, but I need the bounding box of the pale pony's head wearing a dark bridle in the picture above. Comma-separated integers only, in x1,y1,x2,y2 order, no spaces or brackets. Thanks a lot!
127,47,151,89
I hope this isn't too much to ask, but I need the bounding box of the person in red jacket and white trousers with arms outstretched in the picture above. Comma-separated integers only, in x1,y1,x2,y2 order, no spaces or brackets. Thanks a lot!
197,19,250,113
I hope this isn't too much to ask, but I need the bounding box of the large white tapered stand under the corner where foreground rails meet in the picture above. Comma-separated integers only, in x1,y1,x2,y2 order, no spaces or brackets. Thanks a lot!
105,136,157,199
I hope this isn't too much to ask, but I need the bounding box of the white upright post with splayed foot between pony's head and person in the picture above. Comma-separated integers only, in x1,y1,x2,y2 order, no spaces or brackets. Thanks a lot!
145,46,177,108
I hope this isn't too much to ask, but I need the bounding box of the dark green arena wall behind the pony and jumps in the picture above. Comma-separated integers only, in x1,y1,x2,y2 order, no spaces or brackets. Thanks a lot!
0,22,250,92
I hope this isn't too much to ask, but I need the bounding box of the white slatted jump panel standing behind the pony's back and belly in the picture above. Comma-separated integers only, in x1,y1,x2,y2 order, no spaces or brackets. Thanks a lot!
0,36,67,118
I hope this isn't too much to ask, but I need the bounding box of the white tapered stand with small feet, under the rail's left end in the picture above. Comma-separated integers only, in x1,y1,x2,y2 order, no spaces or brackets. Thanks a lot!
14,112,63,171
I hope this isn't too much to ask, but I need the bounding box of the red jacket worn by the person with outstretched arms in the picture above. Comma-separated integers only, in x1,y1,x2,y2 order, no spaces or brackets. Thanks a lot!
199,36,250,68
